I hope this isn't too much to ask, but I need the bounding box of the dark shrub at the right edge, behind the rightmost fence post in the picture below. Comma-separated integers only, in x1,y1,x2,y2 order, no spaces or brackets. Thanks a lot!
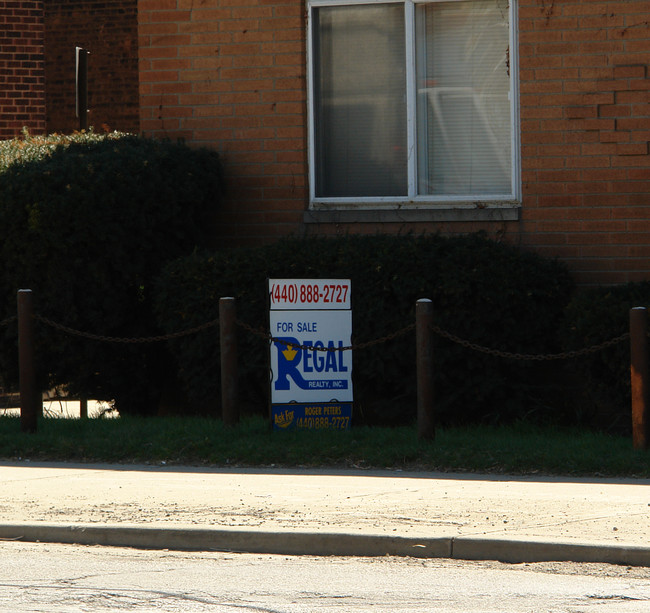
564,282,650,433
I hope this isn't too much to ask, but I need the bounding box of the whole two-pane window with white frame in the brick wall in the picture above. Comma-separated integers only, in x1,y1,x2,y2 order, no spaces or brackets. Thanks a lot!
309,0,517,207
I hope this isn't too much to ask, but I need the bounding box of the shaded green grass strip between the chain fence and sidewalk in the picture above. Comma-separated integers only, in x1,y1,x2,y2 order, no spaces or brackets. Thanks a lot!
0,416,650,478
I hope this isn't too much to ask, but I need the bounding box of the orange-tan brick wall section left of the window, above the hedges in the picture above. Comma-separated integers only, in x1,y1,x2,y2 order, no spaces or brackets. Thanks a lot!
138,0,307,244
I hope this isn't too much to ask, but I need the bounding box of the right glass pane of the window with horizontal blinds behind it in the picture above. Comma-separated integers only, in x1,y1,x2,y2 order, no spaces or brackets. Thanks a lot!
415,0,511,194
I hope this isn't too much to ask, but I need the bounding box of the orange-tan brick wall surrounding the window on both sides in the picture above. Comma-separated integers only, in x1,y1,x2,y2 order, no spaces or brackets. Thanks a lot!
139,0,650,283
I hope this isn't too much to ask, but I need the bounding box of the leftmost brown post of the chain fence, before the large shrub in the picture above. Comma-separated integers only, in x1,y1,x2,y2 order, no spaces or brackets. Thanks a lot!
18,289,38,432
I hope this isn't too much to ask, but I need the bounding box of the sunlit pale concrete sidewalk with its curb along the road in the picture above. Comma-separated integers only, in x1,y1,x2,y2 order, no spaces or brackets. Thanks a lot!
0,462,650,566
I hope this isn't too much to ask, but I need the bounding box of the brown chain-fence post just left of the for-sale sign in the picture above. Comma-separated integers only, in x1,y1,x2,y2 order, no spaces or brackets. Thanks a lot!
219,297,239,426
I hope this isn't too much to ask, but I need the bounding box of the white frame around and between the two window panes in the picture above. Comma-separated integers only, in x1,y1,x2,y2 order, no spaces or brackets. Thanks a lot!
306,0,521,214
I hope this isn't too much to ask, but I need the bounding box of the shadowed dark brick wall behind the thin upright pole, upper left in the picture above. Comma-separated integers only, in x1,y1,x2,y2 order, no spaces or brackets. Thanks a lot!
45,0,140,133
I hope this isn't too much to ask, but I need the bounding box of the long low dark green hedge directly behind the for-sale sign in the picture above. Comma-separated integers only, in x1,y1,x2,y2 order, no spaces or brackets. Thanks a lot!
156,235,573,424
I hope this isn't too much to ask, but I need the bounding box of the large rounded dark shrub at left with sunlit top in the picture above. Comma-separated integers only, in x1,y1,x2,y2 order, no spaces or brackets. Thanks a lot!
0,134,221,413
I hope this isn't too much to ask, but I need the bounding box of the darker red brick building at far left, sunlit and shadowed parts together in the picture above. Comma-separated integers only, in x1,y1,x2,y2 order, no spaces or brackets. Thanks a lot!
0,0,139,139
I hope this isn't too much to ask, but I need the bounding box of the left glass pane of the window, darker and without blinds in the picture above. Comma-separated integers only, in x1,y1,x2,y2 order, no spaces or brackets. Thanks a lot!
313,4,407,196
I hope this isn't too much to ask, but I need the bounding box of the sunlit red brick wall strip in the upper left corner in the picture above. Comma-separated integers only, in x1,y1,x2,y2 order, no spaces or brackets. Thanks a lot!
0,0,45,140
